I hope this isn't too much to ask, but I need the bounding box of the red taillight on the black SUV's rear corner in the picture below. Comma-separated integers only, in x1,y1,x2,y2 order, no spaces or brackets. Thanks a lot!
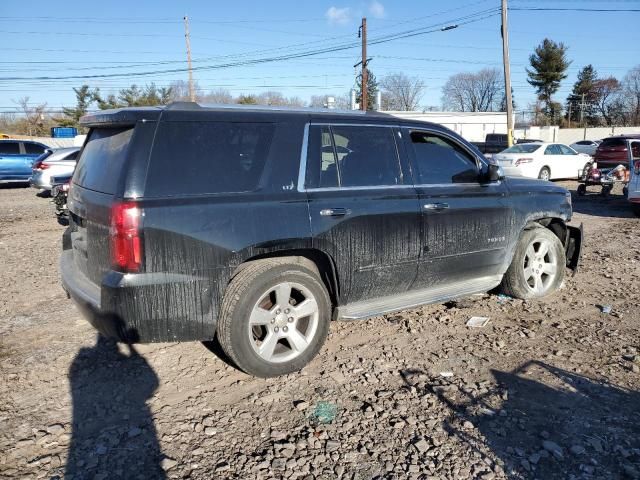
110,201,142,272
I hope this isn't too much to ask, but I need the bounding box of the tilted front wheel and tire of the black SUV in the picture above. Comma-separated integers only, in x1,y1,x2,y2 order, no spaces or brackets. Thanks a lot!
501,227,566,299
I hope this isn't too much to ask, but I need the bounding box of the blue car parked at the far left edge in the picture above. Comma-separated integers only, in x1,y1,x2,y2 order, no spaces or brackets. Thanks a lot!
0,140,48,183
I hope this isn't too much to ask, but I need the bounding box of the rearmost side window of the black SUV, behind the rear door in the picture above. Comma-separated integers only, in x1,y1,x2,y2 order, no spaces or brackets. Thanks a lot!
145,122,275,196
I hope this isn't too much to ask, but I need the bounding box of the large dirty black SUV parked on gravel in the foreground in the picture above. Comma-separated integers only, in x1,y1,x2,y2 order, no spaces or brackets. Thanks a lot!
61,103,582,377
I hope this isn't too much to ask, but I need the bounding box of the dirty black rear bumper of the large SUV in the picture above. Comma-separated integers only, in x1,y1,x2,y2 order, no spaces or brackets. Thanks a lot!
60,250,217,343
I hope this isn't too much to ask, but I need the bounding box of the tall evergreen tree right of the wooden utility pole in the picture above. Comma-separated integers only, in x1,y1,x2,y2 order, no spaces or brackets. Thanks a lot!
527,38,571,123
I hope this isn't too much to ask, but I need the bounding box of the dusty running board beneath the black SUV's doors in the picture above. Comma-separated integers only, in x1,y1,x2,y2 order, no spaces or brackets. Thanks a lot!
336,275,502,320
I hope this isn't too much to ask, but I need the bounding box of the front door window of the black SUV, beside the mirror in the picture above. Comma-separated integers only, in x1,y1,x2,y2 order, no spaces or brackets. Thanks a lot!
411,131,478,185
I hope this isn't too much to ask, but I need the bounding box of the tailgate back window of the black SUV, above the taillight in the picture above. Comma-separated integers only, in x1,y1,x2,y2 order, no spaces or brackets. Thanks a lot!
73,127,133,194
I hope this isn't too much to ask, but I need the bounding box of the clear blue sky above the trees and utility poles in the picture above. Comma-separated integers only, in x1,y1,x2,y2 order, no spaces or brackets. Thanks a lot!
0,0,640,112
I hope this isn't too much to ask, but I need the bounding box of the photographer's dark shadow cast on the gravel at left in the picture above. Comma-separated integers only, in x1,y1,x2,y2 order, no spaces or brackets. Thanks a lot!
65,334,165,480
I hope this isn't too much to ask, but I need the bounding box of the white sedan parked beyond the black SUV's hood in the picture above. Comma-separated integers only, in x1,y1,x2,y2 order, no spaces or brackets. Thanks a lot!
493,143,591,180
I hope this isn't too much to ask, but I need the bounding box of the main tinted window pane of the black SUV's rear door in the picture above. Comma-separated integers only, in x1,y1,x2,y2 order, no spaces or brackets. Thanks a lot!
331,126,402,187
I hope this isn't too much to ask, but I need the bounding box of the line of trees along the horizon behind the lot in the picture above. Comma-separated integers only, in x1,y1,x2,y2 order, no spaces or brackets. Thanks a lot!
0,38,640,135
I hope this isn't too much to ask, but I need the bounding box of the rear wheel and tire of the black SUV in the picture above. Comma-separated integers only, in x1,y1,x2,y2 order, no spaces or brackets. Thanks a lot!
217,257,331,378
